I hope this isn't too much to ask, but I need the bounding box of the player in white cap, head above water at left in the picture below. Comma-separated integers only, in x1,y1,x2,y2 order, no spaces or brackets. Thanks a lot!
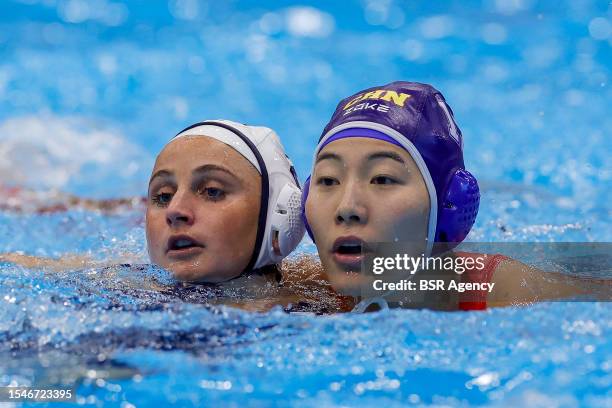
146,120,304,282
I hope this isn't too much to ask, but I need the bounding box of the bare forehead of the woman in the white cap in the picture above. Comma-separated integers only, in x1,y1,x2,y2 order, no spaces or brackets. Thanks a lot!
154,135,257,173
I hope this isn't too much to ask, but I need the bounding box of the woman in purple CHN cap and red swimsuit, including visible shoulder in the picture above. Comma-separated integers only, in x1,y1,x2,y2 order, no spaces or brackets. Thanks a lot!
302,82,609,311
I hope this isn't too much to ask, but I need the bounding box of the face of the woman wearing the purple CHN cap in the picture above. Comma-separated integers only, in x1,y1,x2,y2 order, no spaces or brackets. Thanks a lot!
306,138,430,296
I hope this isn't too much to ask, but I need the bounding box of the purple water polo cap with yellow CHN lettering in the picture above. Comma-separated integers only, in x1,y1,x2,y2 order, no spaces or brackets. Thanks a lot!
303,81,480,253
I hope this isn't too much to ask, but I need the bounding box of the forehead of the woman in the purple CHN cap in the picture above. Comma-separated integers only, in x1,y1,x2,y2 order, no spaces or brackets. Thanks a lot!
317,137,416,168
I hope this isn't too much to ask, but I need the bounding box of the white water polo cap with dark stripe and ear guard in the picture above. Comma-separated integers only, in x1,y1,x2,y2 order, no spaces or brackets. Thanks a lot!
173,120,304,270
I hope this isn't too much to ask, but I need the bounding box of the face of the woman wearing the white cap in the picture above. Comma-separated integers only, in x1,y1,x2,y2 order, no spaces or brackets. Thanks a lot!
146,136,261,282
